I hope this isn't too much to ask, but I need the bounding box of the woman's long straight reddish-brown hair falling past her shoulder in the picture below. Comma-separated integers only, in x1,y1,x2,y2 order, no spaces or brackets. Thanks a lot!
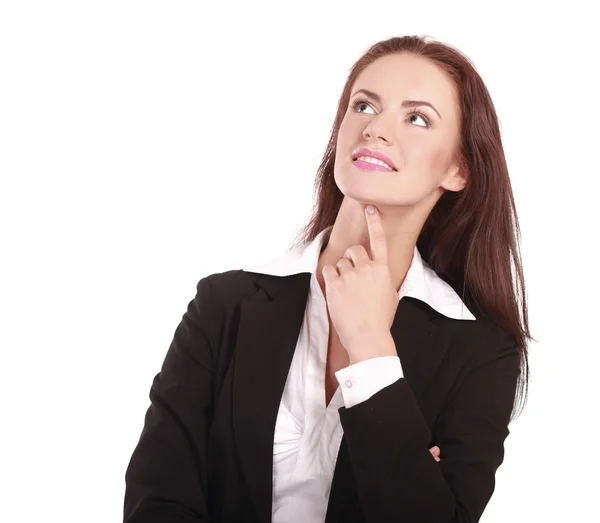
294,36,532,420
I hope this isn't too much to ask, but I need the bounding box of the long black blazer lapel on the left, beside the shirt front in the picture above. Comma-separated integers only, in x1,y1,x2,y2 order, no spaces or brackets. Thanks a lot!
232,273,310,523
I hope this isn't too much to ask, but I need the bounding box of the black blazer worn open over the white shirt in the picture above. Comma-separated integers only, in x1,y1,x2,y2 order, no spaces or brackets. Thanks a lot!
124,270,519,523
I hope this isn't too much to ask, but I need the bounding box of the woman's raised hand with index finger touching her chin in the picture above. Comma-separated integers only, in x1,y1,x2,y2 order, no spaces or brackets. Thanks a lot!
322,205,398,365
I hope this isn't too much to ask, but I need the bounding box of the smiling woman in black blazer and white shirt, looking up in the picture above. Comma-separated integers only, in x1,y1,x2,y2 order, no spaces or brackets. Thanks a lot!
124,37,530,523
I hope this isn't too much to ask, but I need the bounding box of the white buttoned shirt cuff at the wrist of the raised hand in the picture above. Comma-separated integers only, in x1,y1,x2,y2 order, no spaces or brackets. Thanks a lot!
335,356,404,409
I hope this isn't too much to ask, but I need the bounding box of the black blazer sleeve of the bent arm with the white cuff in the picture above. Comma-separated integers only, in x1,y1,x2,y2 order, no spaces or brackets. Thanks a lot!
339,326,519,523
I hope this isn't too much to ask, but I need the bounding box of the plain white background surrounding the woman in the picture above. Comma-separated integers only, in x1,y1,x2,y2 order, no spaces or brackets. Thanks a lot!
0,0,600,523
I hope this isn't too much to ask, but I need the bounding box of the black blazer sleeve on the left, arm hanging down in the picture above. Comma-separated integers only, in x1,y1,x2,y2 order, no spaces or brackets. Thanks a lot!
123,278,217,523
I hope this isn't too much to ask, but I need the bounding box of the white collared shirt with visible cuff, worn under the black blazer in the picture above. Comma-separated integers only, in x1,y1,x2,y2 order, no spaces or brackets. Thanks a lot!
244,226,475,523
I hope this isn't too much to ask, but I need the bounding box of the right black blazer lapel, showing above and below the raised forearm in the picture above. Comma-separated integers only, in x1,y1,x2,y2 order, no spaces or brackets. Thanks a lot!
325,297,447,523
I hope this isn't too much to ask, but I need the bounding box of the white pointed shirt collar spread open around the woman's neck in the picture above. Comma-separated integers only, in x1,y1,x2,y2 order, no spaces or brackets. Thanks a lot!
243,225,475,320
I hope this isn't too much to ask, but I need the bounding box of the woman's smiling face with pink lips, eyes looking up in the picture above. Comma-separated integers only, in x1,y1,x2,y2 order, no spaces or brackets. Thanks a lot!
334,53,465,212
